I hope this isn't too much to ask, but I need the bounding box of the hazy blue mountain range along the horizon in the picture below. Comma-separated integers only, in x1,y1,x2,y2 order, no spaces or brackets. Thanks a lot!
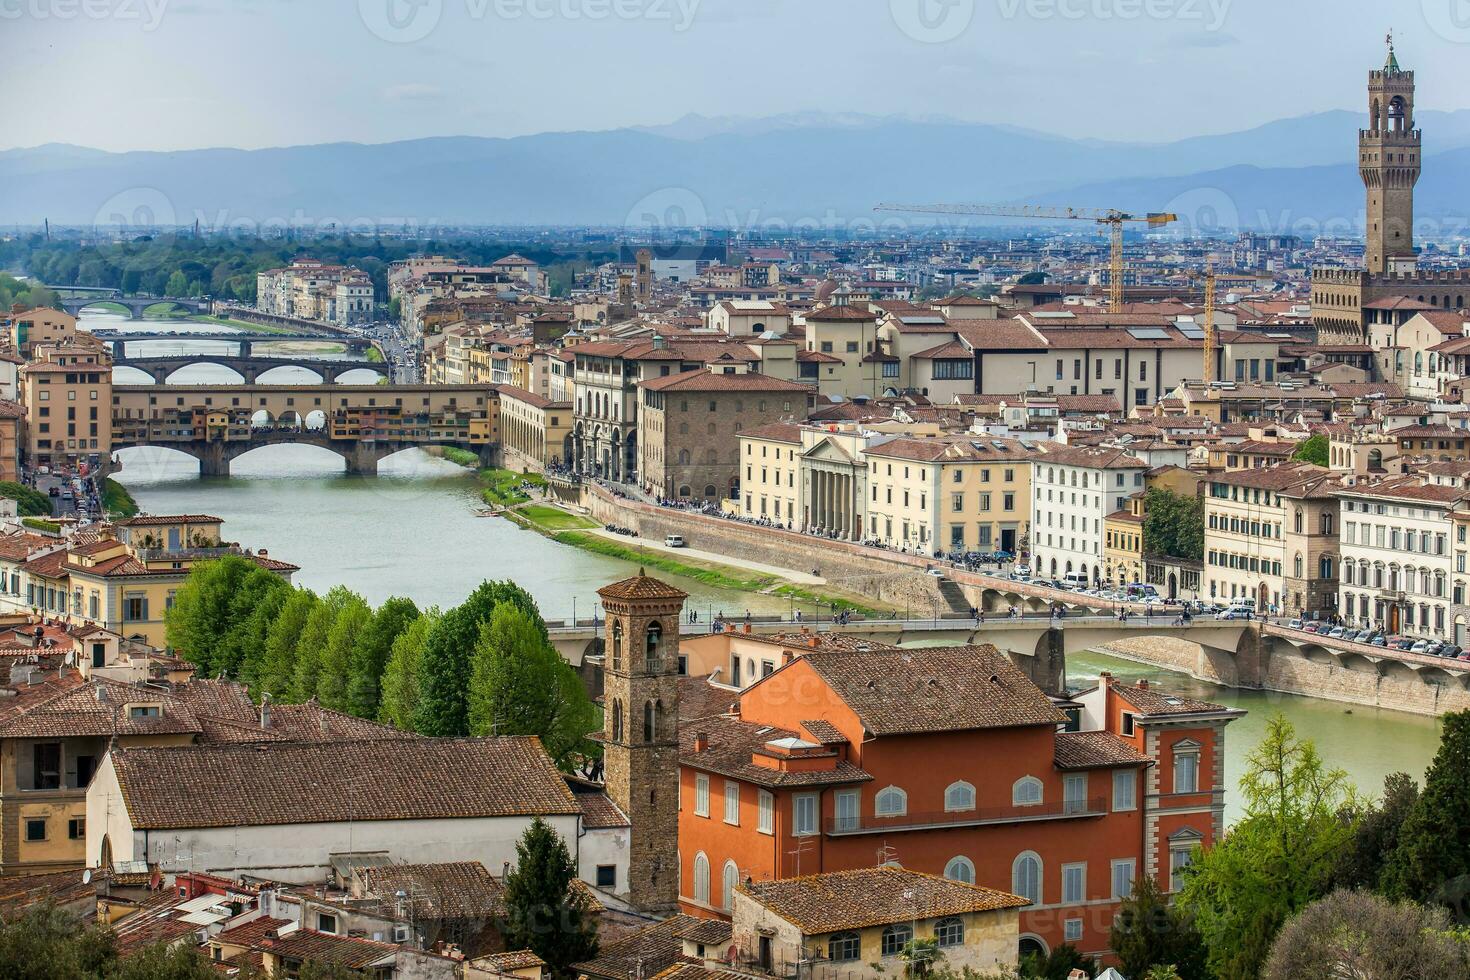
0,110,1470,234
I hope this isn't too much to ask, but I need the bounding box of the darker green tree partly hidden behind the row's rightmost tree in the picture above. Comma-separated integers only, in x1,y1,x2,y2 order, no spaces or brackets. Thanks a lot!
415,582,547,738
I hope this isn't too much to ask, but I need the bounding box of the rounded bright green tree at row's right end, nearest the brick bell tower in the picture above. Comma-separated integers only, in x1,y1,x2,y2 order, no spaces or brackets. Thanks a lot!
469,602,597,768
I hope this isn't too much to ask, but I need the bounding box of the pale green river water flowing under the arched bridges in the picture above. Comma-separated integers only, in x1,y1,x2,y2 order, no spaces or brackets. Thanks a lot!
85,317,1439,820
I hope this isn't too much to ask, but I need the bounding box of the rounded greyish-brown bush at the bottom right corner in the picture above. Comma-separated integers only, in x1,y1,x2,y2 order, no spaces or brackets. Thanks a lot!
1261,890,1470,980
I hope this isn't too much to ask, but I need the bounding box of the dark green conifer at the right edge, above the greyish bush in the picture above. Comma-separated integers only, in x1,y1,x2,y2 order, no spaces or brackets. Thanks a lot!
1382,710,1470,902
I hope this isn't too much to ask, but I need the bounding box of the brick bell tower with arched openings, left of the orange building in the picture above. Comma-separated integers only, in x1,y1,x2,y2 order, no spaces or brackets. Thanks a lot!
597,569,689,912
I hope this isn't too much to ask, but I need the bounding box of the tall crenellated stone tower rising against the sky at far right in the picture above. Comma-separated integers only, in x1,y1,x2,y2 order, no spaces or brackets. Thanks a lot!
1358,34,1420,276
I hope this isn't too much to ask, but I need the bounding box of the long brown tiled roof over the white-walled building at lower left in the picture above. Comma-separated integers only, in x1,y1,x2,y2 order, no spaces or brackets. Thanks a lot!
112,738,581,830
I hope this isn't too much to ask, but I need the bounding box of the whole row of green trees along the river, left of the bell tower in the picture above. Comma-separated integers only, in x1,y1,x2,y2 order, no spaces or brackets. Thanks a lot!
166,555,598,767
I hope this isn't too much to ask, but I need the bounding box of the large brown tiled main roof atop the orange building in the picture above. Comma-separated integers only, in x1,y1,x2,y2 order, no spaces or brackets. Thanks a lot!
793,644,1067,736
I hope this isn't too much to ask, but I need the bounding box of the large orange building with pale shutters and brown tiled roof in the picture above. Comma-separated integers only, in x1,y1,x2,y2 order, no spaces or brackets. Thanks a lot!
679,641,1242,954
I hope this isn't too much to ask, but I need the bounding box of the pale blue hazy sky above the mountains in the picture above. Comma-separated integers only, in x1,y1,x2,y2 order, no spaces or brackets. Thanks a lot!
0,0,1470,150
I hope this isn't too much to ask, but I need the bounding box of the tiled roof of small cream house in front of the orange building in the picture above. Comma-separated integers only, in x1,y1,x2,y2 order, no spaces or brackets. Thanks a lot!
736,867,1028,936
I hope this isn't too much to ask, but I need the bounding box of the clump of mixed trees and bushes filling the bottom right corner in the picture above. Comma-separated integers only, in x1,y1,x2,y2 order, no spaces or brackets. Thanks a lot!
1110,711,1470,980
